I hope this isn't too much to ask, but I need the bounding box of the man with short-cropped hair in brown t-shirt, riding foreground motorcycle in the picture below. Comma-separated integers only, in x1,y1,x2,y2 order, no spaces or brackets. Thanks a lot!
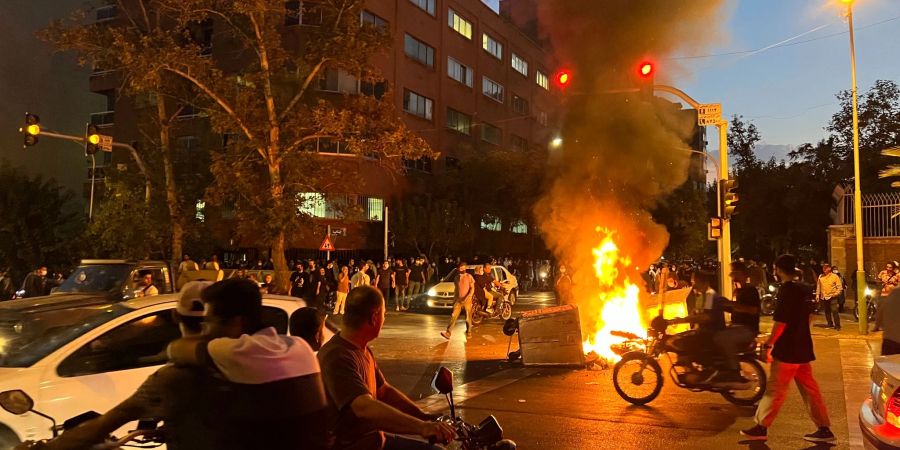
318,286,456,450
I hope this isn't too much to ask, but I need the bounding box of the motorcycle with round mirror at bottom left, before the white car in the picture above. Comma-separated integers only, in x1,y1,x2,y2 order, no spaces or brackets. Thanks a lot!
0,389,165,450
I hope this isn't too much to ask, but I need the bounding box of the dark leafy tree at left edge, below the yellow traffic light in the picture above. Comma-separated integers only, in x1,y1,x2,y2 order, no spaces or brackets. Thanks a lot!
0,162,84,279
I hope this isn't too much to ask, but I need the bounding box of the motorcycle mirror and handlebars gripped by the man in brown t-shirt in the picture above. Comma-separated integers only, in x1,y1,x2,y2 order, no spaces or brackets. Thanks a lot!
431,367,516,450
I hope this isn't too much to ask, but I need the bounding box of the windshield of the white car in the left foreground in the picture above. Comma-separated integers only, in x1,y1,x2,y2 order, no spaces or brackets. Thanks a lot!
0,300,132,367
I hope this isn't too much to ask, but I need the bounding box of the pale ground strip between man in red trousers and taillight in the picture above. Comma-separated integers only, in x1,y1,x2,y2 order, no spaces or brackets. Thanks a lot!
838,339,874,450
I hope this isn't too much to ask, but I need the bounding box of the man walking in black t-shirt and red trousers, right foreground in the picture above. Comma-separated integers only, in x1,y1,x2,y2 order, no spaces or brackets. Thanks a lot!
741,255,835,442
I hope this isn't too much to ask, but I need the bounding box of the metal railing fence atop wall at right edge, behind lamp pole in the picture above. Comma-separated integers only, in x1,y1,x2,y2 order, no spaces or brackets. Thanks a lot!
837,192,900,237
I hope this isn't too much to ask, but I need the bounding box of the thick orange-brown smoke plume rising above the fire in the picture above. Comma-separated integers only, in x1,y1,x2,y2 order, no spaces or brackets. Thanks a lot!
535,0,724,331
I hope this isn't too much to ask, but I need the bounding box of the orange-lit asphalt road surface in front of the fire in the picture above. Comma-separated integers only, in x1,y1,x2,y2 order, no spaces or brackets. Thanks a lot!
364,293,869,450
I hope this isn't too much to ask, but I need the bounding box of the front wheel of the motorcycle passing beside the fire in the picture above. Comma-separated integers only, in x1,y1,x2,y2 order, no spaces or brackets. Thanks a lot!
613,352,663,405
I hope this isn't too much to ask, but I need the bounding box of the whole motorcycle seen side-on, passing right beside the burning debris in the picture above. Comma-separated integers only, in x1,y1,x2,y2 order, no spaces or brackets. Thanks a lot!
613,317,766,406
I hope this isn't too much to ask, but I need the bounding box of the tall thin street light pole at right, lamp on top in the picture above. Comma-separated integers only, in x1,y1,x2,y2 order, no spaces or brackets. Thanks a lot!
842,0,869,334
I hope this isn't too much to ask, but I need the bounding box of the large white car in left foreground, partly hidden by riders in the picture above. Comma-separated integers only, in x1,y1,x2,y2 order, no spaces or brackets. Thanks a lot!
0,294,316,450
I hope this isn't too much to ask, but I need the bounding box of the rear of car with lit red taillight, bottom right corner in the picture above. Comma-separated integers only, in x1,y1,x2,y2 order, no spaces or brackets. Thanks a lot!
859,355,900,450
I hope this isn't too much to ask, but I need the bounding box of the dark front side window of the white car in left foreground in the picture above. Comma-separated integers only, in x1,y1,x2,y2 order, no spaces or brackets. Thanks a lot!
57,309,181,377
